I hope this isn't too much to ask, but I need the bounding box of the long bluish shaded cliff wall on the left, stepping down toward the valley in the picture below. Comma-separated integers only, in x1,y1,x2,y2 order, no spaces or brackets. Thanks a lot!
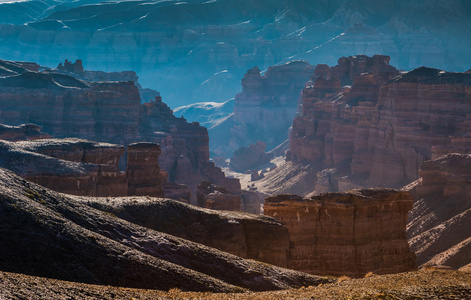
0,61,240,203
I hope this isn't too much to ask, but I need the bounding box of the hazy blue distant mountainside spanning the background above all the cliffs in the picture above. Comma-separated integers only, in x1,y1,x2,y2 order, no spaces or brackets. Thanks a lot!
0,0,471,107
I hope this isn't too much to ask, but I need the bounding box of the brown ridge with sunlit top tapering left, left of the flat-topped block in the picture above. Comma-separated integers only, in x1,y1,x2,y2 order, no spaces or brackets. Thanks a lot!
79,197,289,267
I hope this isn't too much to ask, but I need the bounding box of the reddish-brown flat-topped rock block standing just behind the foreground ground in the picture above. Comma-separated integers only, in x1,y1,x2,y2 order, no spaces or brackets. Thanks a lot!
264,189,417,277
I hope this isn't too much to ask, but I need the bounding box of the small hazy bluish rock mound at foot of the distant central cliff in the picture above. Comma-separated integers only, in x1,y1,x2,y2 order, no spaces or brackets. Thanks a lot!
229,141,273,172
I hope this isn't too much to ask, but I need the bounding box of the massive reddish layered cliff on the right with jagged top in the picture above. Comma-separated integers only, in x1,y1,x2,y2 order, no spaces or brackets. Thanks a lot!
287,56,471,191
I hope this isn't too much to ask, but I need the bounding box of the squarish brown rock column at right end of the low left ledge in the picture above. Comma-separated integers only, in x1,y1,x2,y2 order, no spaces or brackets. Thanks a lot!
126,142,163,197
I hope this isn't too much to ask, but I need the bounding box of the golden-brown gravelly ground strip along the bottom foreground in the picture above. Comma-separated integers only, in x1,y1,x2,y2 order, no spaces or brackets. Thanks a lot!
0,270,471,300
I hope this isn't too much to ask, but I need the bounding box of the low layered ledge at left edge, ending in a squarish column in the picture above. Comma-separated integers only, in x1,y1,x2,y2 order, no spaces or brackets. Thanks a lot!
0,139,166,196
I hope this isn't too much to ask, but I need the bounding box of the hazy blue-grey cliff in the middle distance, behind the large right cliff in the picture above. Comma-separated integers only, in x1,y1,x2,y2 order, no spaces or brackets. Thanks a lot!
221,61,314,154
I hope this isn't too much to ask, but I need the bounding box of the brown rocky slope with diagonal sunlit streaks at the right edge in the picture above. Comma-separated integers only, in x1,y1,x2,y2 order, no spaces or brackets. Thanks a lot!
404,154,471,268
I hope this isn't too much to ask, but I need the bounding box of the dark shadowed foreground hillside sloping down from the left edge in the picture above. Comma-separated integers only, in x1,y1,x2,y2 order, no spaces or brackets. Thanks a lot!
0,169,327,292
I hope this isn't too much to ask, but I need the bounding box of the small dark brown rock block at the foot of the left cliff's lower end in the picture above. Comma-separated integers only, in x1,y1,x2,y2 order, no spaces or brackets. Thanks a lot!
196,181,241,210
